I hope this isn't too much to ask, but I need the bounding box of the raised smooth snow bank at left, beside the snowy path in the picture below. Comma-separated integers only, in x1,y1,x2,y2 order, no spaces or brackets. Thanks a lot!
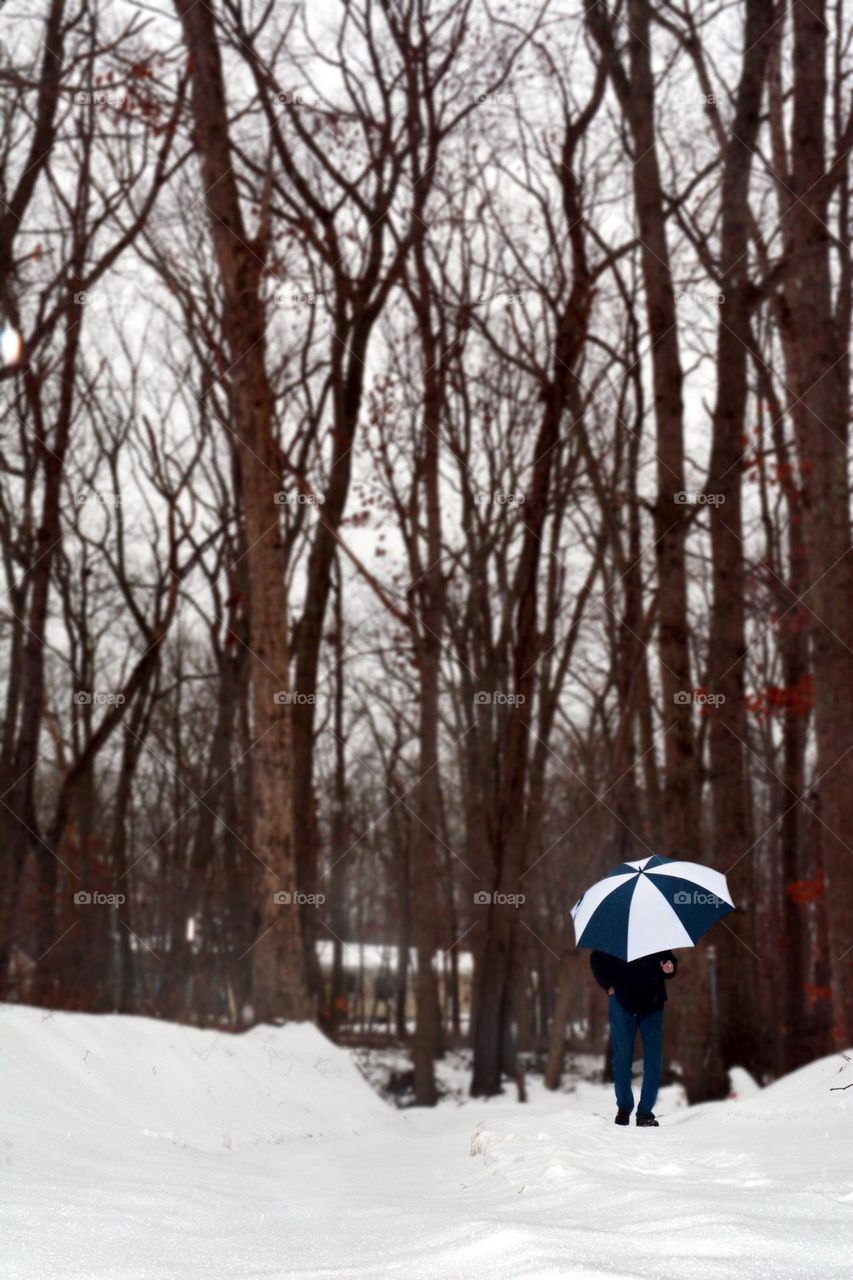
0,1005,388,1151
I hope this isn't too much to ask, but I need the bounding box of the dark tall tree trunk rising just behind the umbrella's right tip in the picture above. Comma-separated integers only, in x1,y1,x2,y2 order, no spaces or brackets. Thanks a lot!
701,0,775,1097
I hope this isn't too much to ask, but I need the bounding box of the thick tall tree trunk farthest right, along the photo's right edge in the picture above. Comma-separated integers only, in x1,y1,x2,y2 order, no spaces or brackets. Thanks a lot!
781,0,853,1048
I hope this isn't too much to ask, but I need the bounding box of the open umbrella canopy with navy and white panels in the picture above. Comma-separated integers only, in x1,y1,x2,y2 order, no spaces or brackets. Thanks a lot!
571,854,734,960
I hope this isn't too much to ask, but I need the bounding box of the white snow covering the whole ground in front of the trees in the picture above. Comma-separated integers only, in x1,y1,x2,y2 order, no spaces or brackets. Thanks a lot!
0,1006,853,1280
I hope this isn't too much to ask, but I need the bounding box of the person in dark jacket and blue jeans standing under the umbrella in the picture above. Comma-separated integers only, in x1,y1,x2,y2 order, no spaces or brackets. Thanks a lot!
589,951,679,1129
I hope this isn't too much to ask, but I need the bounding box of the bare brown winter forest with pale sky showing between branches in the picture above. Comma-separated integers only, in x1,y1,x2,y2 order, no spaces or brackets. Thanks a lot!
0,0,853,1106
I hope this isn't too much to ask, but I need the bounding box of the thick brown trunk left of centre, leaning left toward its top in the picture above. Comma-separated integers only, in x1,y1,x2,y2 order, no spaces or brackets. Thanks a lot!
175,0,310,1021
